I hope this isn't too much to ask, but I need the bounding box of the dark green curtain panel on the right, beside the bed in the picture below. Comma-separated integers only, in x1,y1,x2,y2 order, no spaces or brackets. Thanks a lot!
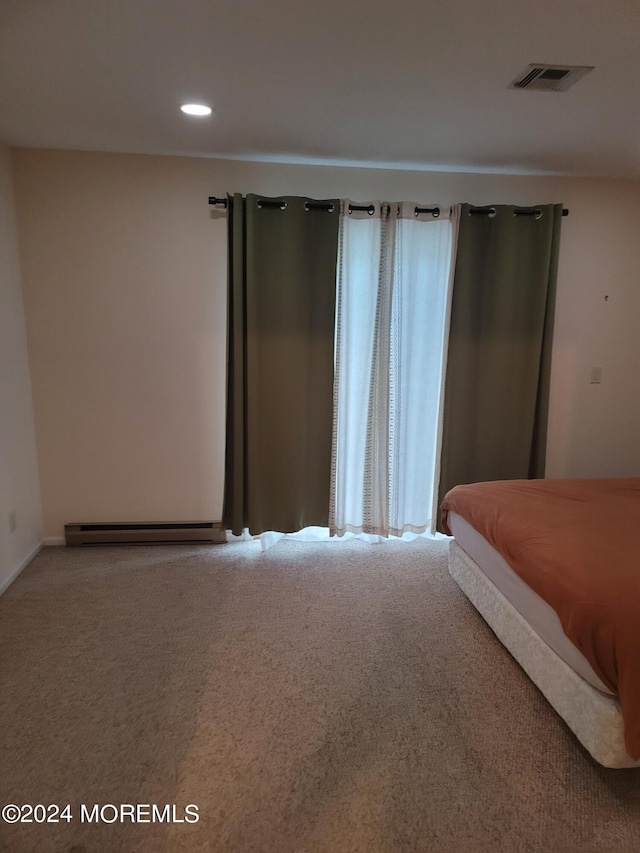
439,204,562,512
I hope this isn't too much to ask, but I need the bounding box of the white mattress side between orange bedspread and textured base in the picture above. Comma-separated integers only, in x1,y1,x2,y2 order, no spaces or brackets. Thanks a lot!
449,512,614,695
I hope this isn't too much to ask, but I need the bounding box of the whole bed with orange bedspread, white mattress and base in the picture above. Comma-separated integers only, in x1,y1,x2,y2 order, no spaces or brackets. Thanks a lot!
442,478,640,768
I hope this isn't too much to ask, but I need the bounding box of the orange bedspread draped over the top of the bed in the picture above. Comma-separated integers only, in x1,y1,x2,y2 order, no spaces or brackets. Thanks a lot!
442,478,640,759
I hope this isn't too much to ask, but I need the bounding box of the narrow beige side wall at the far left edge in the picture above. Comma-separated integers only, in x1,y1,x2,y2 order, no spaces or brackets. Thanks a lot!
0,146,42,591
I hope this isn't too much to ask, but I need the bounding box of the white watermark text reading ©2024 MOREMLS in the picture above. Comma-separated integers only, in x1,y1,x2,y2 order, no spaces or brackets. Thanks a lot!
0,803,200,823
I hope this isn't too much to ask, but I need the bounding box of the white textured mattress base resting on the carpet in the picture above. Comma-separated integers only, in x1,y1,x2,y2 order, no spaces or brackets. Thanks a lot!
449,540,640,767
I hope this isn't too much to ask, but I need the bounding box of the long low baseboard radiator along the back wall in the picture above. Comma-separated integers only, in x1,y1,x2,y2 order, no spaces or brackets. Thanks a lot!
64,521,227,545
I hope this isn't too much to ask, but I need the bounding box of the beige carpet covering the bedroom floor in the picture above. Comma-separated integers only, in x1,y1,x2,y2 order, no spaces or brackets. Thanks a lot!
0,541,640,853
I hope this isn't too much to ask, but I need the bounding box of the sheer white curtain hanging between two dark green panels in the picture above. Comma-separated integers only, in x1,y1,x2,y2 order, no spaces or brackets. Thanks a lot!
329,201,459,536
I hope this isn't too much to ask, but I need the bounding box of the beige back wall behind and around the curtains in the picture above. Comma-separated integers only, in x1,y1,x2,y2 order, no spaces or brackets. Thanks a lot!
15,150,640,537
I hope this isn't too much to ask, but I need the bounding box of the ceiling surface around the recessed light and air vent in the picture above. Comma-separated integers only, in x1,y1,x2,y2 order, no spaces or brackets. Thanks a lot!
0,0,640,177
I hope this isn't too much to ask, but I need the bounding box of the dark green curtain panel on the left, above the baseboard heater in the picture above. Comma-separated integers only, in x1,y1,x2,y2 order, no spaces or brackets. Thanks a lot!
223,194,340,535
